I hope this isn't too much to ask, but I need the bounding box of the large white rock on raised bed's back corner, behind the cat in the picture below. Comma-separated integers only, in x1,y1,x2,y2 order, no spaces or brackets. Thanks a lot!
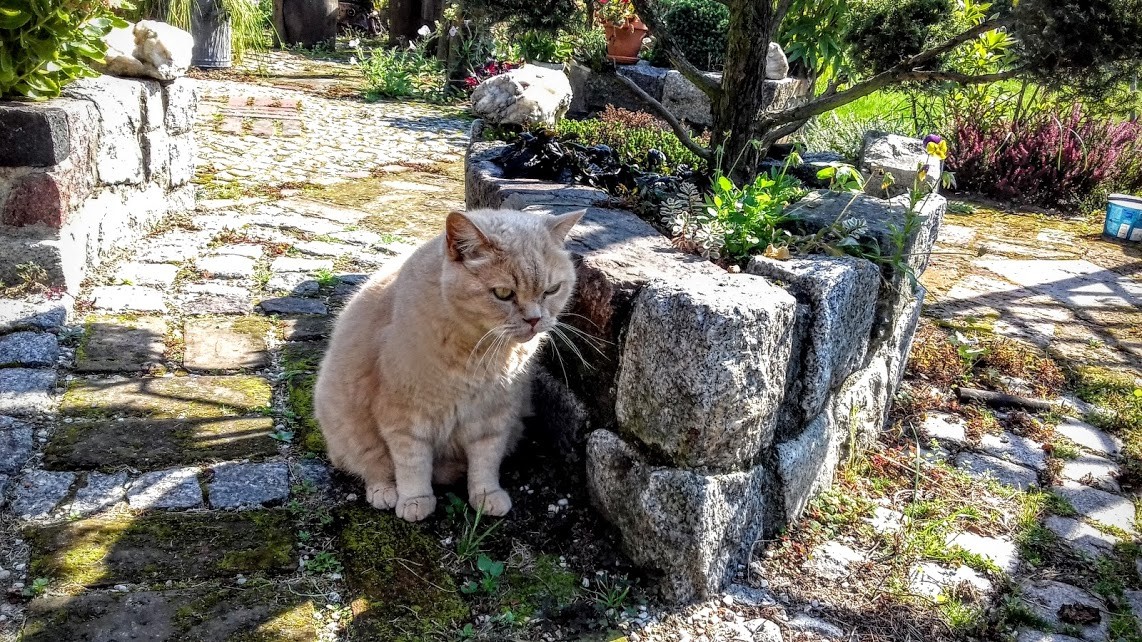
472,65,571,127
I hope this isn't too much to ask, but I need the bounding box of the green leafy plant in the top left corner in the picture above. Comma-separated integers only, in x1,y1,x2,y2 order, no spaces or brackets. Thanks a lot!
0,0,127,101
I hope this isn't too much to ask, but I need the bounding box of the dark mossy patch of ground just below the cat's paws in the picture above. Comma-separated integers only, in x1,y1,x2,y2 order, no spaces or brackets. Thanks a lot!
337,506,468,642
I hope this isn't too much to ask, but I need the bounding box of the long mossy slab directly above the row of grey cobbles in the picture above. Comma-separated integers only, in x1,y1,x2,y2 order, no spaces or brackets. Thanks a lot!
43,417,278,471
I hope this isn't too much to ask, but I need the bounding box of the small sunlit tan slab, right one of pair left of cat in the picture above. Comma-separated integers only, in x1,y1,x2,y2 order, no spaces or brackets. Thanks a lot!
183,316,273,370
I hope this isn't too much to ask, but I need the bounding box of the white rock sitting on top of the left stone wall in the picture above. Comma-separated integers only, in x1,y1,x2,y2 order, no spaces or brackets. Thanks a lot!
97,21,194,80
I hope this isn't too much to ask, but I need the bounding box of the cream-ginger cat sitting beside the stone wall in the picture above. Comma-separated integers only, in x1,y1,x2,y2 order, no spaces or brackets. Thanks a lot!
314,209,584,521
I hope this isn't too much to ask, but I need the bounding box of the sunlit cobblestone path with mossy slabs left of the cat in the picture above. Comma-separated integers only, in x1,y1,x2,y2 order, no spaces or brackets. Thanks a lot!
0,66,467,642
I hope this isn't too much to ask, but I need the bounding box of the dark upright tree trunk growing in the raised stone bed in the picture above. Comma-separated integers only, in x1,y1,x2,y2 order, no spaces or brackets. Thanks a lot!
711,0,773,177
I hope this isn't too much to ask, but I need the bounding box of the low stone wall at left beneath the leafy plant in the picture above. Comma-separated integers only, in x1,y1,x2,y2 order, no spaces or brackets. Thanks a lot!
0,75,198,292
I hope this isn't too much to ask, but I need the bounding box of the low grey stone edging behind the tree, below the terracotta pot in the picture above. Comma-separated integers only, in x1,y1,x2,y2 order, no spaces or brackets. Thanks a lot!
568,62,810,127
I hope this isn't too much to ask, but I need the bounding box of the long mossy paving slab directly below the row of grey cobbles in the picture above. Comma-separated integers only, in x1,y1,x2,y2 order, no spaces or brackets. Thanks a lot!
24,509,297,588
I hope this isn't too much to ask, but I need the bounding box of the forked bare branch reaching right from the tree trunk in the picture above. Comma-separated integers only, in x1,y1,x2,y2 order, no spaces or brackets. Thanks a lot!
758,19,1019,130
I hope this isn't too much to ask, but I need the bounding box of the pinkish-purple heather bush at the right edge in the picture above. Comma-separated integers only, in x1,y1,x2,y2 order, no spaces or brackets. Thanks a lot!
948,104,1142,207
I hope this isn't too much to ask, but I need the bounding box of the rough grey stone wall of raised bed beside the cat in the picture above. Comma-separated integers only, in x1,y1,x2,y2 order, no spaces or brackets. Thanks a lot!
466,121,946,601
